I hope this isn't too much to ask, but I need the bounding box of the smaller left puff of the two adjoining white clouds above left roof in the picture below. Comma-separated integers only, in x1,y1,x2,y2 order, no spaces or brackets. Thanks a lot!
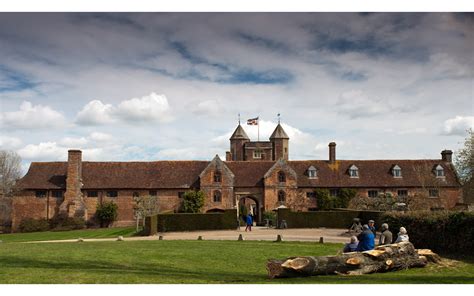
76,100,114,125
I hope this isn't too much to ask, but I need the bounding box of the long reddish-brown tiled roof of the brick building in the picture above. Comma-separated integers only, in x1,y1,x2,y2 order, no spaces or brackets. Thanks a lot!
18,159,460,189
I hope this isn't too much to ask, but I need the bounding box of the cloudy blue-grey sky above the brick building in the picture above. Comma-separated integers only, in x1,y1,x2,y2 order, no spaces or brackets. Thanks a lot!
0,13,474,171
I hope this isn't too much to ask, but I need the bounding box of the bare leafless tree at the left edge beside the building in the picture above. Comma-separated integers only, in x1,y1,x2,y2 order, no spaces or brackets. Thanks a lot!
0,150,21,196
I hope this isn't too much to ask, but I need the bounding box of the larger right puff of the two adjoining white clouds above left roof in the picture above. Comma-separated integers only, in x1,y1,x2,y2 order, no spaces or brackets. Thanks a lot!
116,92,170,122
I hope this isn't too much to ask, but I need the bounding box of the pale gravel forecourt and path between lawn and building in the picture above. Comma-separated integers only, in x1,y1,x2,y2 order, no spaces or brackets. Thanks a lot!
31,227,349,243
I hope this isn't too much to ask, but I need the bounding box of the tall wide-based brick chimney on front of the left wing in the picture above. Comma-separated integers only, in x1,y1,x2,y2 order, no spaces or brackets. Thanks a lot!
59,150,87,219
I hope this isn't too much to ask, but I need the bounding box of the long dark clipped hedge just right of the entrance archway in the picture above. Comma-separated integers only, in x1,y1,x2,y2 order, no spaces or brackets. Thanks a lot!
277,209,383,229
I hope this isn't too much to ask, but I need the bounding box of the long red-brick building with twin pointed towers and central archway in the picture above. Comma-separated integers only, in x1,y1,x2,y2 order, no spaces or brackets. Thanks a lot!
12,124,462,230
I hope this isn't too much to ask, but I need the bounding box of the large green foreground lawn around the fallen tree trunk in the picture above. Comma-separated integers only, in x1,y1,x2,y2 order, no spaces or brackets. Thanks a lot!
0,240,474,284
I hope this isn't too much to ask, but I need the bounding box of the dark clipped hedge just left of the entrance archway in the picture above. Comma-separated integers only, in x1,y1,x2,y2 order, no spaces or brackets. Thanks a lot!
145,210,237,235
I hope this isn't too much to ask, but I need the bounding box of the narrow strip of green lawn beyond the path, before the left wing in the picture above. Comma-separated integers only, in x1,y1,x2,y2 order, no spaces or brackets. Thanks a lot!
0,227,135,242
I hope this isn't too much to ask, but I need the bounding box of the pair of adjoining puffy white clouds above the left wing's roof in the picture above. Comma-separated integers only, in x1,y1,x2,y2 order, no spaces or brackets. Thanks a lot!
76,92,171,125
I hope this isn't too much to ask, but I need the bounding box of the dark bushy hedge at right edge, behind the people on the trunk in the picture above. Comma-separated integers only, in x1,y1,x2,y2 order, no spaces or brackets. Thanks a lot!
382,211,474,254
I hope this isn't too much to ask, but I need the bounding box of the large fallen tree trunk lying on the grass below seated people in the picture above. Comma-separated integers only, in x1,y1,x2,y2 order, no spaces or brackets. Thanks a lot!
267,242,439,278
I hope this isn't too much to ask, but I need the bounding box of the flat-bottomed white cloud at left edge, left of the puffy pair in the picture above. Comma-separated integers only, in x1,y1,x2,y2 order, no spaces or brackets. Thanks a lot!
0,101,65,129
